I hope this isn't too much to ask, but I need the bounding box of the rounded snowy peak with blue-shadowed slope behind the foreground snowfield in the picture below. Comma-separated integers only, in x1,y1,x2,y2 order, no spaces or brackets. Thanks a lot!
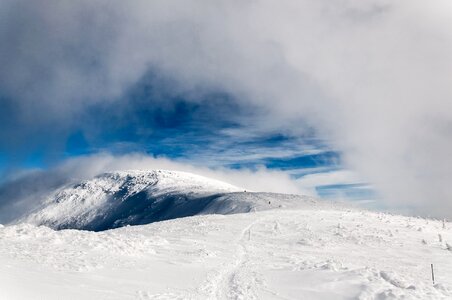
19,170,313,231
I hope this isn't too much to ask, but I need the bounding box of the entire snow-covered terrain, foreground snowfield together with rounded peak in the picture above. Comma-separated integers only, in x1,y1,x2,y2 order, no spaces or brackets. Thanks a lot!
0,171,452,300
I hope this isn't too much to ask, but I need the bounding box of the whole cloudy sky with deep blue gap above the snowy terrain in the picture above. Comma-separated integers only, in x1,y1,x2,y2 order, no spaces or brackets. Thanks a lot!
0,0,452,217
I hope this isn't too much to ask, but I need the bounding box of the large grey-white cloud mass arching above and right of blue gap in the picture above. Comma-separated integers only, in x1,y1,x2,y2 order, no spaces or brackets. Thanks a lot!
0,0,452,216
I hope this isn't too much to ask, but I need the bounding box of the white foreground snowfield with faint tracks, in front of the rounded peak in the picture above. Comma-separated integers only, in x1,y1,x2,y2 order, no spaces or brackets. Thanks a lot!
0,208,452,300
